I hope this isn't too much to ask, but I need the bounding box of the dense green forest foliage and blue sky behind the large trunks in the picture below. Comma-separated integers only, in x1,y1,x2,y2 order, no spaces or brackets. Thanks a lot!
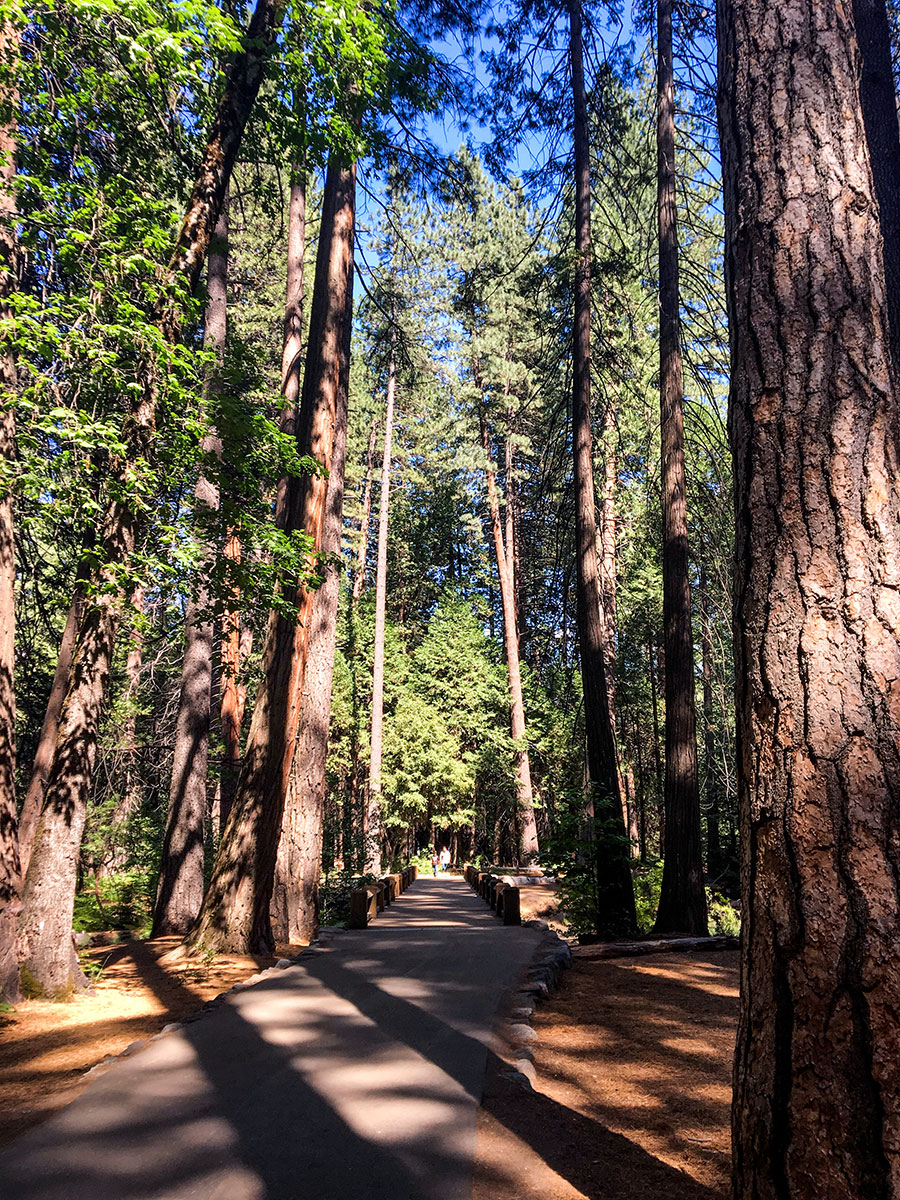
7,2,737,955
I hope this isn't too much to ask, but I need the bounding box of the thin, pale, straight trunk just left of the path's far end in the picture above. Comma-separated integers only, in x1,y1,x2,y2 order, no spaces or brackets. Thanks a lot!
365,326,396,875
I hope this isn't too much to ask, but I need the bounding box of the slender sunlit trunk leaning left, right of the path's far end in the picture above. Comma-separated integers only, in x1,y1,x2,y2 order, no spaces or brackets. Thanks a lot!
479,407,539,865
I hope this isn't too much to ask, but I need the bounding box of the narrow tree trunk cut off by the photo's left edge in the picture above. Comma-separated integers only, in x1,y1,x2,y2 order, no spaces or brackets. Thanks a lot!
0,19,22,1001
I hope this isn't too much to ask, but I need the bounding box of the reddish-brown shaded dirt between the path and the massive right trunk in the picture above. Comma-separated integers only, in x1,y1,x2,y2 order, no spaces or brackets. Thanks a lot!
474,947,738,1200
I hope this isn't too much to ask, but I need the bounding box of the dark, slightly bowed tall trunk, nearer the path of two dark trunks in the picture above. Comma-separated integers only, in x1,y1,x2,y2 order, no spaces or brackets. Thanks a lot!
569,0,637,936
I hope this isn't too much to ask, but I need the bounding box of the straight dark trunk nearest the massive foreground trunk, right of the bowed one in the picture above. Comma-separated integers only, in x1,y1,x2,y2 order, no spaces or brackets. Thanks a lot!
654,0,708,937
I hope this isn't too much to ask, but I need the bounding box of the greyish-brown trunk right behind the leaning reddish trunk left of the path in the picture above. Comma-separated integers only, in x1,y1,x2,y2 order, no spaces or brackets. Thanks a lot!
270,289,353,944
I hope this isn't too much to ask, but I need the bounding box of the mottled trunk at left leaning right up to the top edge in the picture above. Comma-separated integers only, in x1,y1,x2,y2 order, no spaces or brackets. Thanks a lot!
19,0,280,994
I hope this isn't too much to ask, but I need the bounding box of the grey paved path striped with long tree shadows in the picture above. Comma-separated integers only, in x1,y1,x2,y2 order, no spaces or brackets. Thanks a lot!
0,876,540,1200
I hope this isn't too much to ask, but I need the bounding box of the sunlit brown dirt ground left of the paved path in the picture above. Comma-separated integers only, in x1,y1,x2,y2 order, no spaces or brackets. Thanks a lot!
0,937,282,1146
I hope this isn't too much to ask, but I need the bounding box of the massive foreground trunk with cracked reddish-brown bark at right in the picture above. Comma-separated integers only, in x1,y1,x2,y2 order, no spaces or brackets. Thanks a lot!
719,0,900,1200
